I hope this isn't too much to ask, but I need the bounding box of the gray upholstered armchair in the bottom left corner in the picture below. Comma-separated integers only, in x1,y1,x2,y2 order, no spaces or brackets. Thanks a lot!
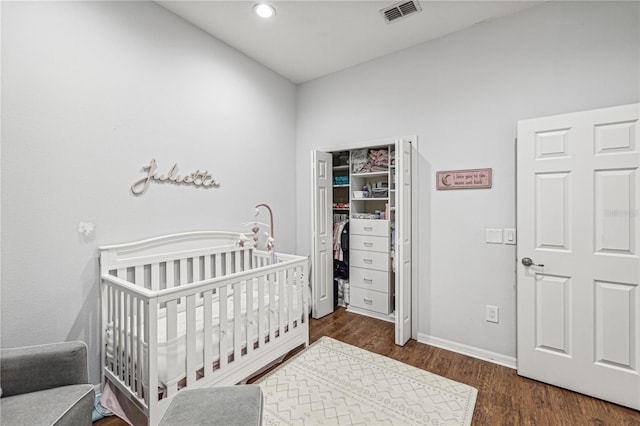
0,342,95,426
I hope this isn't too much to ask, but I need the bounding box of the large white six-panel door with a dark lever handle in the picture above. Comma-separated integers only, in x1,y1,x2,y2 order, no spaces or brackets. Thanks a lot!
517,104,640,409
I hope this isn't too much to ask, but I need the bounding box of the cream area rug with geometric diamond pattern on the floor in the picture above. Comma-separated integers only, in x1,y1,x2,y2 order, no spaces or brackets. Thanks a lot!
256,337,478,426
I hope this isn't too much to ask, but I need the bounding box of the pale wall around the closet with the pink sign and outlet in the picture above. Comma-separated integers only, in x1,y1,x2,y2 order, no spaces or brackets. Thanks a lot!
296,2,640,362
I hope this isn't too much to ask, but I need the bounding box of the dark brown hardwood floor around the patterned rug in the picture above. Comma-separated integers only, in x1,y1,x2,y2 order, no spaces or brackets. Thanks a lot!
95,308,640,426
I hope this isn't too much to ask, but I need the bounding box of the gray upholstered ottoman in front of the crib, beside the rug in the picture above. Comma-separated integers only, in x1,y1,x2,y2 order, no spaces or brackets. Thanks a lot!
159,385,262,426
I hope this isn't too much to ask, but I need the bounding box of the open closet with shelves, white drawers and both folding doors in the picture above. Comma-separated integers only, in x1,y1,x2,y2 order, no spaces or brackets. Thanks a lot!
310,137,416,345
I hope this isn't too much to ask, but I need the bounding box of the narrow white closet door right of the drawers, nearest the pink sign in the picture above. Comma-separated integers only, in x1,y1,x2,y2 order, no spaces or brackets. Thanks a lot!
395,139,412,346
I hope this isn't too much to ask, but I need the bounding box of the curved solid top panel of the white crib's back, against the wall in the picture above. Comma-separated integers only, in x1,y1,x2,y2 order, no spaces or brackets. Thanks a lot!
99,231,240,273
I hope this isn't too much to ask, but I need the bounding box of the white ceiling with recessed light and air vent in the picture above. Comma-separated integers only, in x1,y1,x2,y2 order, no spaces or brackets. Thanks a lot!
157,0,540,83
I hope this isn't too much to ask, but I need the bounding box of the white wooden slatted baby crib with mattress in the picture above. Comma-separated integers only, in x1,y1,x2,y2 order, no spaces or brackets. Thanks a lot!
100,231,309,424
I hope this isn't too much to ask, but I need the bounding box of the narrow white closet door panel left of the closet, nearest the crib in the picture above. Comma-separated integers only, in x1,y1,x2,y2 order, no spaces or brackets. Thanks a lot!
311,151,333,319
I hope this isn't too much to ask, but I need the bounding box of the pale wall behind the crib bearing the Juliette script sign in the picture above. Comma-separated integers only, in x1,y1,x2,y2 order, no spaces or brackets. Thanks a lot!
1,2,295,382
